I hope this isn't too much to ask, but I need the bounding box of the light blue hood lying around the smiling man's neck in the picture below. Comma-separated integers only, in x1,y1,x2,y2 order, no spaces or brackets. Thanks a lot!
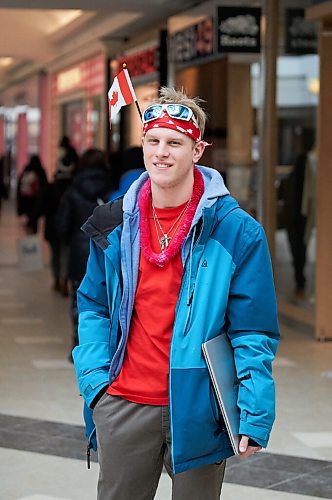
123,165,229,223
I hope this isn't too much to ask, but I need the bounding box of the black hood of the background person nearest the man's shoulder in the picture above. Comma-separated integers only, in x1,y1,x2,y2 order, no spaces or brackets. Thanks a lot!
73,167,111,201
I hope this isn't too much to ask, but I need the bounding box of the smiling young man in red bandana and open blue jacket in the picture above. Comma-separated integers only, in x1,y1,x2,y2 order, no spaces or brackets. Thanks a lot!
73,88,279,500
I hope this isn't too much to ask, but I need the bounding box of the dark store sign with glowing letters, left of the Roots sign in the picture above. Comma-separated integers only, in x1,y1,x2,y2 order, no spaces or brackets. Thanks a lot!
170,18,214,63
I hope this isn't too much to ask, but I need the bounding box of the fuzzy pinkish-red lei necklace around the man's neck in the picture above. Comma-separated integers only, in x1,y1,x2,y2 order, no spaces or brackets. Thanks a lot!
138,167,204,267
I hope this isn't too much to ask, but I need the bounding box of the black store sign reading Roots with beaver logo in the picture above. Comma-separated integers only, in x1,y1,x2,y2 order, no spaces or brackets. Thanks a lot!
218,7,261,52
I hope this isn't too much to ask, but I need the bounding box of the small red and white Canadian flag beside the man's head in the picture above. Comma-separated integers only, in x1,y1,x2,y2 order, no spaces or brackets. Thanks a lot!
108,68,137,124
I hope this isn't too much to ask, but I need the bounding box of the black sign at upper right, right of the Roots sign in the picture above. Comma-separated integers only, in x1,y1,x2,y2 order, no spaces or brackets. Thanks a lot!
285,9,318,54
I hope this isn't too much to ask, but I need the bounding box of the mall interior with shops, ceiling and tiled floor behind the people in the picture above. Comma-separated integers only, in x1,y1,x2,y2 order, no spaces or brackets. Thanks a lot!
0,0,332,500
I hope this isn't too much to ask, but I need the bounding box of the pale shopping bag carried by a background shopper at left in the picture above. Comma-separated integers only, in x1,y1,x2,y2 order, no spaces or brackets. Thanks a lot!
17,234,44,272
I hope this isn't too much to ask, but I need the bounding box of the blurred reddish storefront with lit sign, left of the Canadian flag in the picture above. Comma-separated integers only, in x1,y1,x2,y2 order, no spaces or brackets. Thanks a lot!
51,54,106,175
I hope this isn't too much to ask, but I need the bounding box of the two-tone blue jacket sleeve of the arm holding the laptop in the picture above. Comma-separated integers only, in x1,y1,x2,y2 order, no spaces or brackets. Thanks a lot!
227,224,279,447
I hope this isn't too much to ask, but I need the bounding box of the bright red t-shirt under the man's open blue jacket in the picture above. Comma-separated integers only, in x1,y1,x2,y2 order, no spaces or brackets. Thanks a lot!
107,203,186,405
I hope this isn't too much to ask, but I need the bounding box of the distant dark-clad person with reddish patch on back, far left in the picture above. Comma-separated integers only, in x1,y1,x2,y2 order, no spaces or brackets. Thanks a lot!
16,155,47,234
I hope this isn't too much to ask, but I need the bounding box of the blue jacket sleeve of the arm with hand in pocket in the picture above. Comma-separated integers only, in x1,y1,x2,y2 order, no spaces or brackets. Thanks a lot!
73,241,111,406
